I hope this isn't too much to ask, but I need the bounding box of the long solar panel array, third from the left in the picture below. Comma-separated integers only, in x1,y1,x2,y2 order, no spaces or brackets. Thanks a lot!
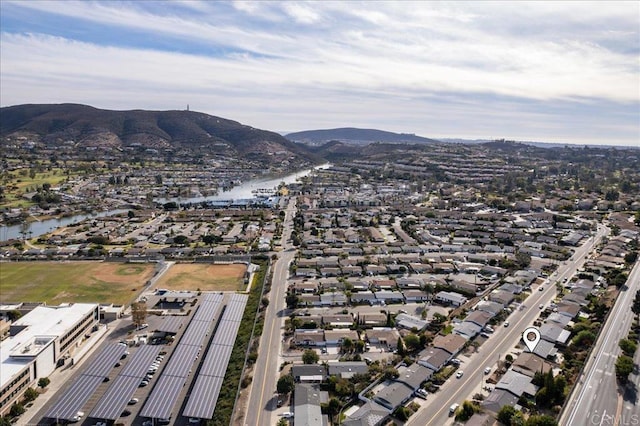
140,293,224,419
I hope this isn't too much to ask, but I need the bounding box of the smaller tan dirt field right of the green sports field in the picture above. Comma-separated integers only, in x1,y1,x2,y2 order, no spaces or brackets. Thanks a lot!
155,263,247,291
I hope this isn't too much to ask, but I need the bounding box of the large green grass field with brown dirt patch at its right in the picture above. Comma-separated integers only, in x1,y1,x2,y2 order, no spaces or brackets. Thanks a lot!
0,262,154,305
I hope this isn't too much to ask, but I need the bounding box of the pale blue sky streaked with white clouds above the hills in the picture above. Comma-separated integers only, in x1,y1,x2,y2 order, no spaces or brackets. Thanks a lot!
0,0,640,146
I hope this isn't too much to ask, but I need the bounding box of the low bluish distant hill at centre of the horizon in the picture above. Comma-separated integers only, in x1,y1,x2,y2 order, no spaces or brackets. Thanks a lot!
285,127,438,145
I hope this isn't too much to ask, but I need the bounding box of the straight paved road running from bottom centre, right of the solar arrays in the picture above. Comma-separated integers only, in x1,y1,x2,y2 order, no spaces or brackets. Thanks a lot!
245,198,296,426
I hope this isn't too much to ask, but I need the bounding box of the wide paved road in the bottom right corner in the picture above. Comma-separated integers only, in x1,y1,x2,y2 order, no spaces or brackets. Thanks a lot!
560,262,640,425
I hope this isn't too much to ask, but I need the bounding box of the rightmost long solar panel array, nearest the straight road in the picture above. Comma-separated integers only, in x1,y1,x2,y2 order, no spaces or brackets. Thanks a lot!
182,294,249,419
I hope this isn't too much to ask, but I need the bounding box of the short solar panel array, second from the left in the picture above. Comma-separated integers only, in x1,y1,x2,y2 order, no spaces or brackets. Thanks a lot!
91,345,162,420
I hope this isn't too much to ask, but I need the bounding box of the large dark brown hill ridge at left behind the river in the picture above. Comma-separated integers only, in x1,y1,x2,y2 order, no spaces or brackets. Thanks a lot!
0,104,317,163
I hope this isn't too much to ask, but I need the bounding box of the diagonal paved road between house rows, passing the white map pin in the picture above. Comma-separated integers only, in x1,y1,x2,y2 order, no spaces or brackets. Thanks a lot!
407,226,608,426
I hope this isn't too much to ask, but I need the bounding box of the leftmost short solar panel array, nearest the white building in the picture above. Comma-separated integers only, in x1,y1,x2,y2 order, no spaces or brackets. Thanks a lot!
45,343,127,421
